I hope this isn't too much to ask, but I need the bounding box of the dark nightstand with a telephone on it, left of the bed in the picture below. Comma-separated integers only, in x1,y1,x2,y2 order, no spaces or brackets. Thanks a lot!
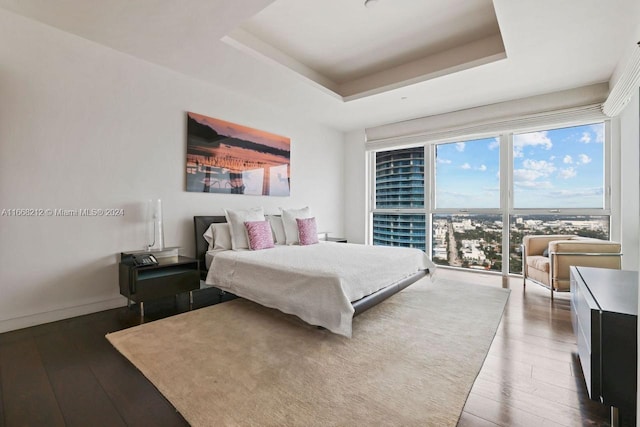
118,252,200,317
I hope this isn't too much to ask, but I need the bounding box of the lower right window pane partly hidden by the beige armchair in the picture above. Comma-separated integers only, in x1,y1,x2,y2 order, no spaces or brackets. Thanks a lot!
509,215,609,274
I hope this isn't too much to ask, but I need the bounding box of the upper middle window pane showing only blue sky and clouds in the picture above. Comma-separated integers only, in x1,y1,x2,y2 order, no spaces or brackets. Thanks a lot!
436,138,500,209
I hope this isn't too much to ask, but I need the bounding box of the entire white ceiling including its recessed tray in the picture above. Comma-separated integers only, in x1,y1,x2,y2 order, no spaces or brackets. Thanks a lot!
0,0,640,132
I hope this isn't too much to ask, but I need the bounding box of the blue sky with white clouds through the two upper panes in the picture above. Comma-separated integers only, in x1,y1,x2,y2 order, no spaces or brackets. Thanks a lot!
436,123,604,208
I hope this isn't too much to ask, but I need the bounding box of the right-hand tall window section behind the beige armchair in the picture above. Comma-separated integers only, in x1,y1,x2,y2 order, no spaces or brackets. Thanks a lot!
509,123,610,273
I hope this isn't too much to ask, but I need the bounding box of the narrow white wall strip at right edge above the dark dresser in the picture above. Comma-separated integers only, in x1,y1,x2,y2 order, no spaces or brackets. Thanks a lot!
619,90,640,270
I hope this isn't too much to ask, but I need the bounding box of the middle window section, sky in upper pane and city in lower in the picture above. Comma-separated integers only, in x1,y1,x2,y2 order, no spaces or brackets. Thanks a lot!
431,136,502,271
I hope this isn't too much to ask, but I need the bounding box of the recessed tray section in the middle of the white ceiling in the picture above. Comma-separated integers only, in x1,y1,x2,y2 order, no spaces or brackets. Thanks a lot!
223,0,506,101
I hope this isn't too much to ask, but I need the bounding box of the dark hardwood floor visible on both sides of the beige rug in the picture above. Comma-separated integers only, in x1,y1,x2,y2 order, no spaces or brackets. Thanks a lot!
0,269,632,427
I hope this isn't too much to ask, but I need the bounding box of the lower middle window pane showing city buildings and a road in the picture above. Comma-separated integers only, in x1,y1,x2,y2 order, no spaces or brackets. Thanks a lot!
432,215,502,271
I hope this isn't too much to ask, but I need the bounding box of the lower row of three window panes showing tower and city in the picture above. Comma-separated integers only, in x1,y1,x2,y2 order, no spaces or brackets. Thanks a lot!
373,213,610,274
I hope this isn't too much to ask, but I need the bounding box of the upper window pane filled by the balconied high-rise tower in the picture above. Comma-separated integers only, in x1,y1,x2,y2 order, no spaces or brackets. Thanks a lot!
376,147,424,208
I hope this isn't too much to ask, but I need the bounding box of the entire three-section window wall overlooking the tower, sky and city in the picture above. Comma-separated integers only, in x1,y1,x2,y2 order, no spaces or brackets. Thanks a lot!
370,122,610,273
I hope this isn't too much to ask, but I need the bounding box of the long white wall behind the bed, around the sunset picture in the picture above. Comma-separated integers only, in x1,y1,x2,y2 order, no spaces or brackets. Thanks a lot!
0,10,344,332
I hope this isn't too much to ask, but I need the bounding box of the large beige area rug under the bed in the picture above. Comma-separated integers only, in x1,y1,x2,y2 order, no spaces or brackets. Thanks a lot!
107,279,509,426
